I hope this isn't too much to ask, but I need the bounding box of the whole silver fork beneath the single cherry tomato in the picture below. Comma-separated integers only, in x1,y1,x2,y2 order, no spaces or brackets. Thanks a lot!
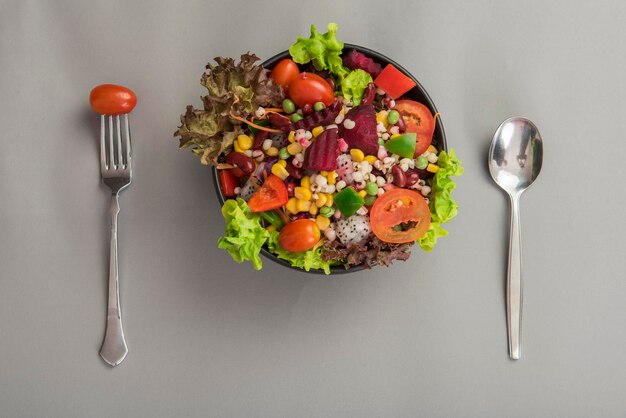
100,113,132,366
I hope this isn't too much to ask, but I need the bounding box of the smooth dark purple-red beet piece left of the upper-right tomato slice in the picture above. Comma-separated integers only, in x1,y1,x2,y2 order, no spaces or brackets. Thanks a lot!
341,105,378,155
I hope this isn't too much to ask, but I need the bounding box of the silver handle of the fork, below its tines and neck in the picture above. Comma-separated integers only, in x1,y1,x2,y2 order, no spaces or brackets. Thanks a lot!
100,193,128,366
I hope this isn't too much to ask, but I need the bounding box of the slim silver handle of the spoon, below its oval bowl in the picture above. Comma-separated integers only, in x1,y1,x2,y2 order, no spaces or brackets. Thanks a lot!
506,194,522,360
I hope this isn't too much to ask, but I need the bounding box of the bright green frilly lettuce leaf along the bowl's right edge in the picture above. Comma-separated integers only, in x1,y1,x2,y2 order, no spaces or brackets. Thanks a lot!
417,149,463,251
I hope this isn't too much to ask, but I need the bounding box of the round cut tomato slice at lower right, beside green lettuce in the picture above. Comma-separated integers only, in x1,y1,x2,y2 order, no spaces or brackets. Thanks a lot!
370,188,430,244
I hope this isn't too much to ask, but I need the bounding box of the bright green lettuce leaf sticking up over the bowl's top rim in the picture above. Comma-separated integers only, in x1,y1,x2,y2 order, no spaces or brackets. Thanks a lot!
289,23,348,75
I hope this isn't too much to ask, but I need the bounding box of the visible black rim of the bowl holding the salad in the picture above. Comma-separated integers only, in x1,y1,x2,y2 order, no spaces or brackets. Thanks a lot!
212,44,448,274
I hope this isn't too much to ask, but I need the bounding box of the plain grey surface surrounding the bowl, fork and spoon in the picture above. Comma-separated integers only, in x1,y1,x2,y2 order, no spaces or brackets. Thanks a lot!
0,0,626,417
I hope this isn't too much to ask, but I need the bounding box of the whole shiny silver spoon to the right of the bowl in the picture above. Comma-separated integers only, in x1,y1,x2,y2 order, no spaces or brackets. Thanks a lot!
489,117,543,360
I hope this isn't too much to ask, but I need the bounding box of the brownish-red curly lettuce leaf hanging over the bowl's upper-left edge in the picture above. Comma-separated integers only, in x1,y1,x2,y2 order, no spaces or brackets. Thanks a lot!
174,53,284,165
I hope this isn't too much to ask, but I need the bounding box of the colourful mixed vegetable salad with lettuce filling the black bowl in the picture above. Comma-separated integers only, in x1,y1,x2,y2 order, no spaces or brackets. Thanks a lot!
175,23,463,274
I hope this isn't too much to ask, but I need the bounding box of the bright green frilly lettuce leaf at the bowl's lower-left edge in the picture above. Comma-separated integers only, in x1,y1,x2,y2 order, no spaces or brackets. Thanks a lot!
217,199,270,270
